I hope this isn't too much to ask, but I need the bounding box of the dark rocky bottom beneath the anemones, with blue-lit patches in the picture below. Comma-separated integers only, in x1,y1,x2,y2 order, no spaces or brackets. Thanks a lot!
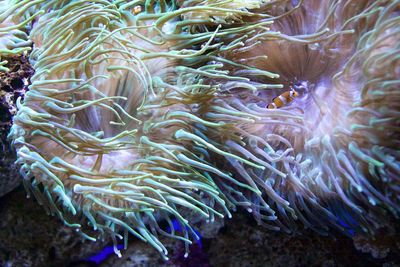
0,187,400,267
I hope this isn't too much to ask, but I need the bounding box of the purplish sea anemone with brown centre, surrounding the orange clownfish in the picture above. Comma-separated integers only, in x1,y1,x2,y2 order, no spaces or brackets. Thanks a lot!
198,0,400,234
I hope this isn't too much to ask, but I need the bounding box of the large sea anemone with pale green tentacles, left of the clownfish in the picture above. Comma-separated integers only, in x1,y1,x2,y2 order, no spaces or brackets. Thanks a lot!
6,0,272,257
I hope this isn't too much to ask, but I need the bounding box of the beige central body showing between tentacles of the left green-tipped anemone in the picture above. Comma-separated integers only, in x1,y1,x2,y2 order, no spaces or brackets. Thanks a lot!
25,12,176,175
